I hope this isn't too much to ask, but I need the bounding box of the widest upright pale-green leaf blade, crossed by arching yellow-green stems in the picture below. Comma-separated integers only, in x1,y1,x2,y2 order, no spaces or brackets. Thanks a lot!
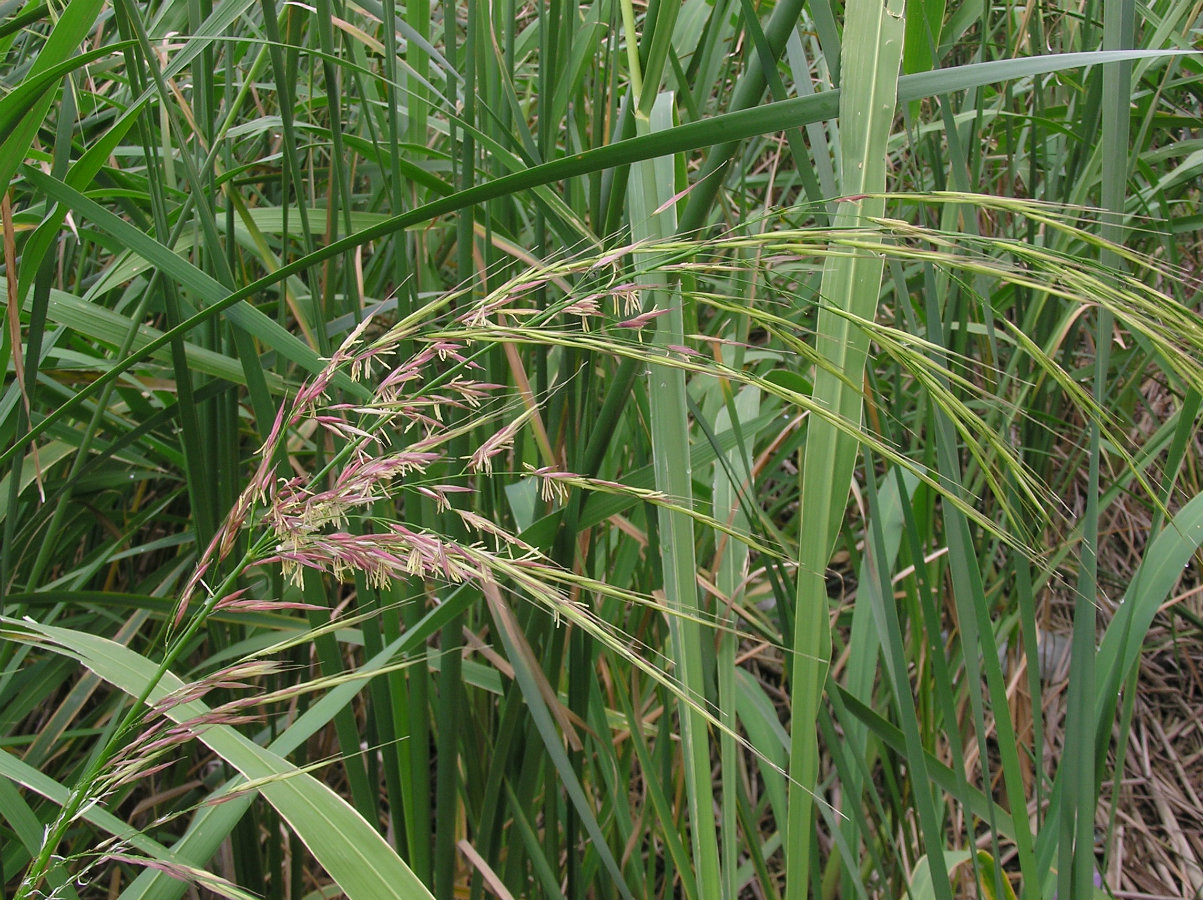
786,0,903,898
